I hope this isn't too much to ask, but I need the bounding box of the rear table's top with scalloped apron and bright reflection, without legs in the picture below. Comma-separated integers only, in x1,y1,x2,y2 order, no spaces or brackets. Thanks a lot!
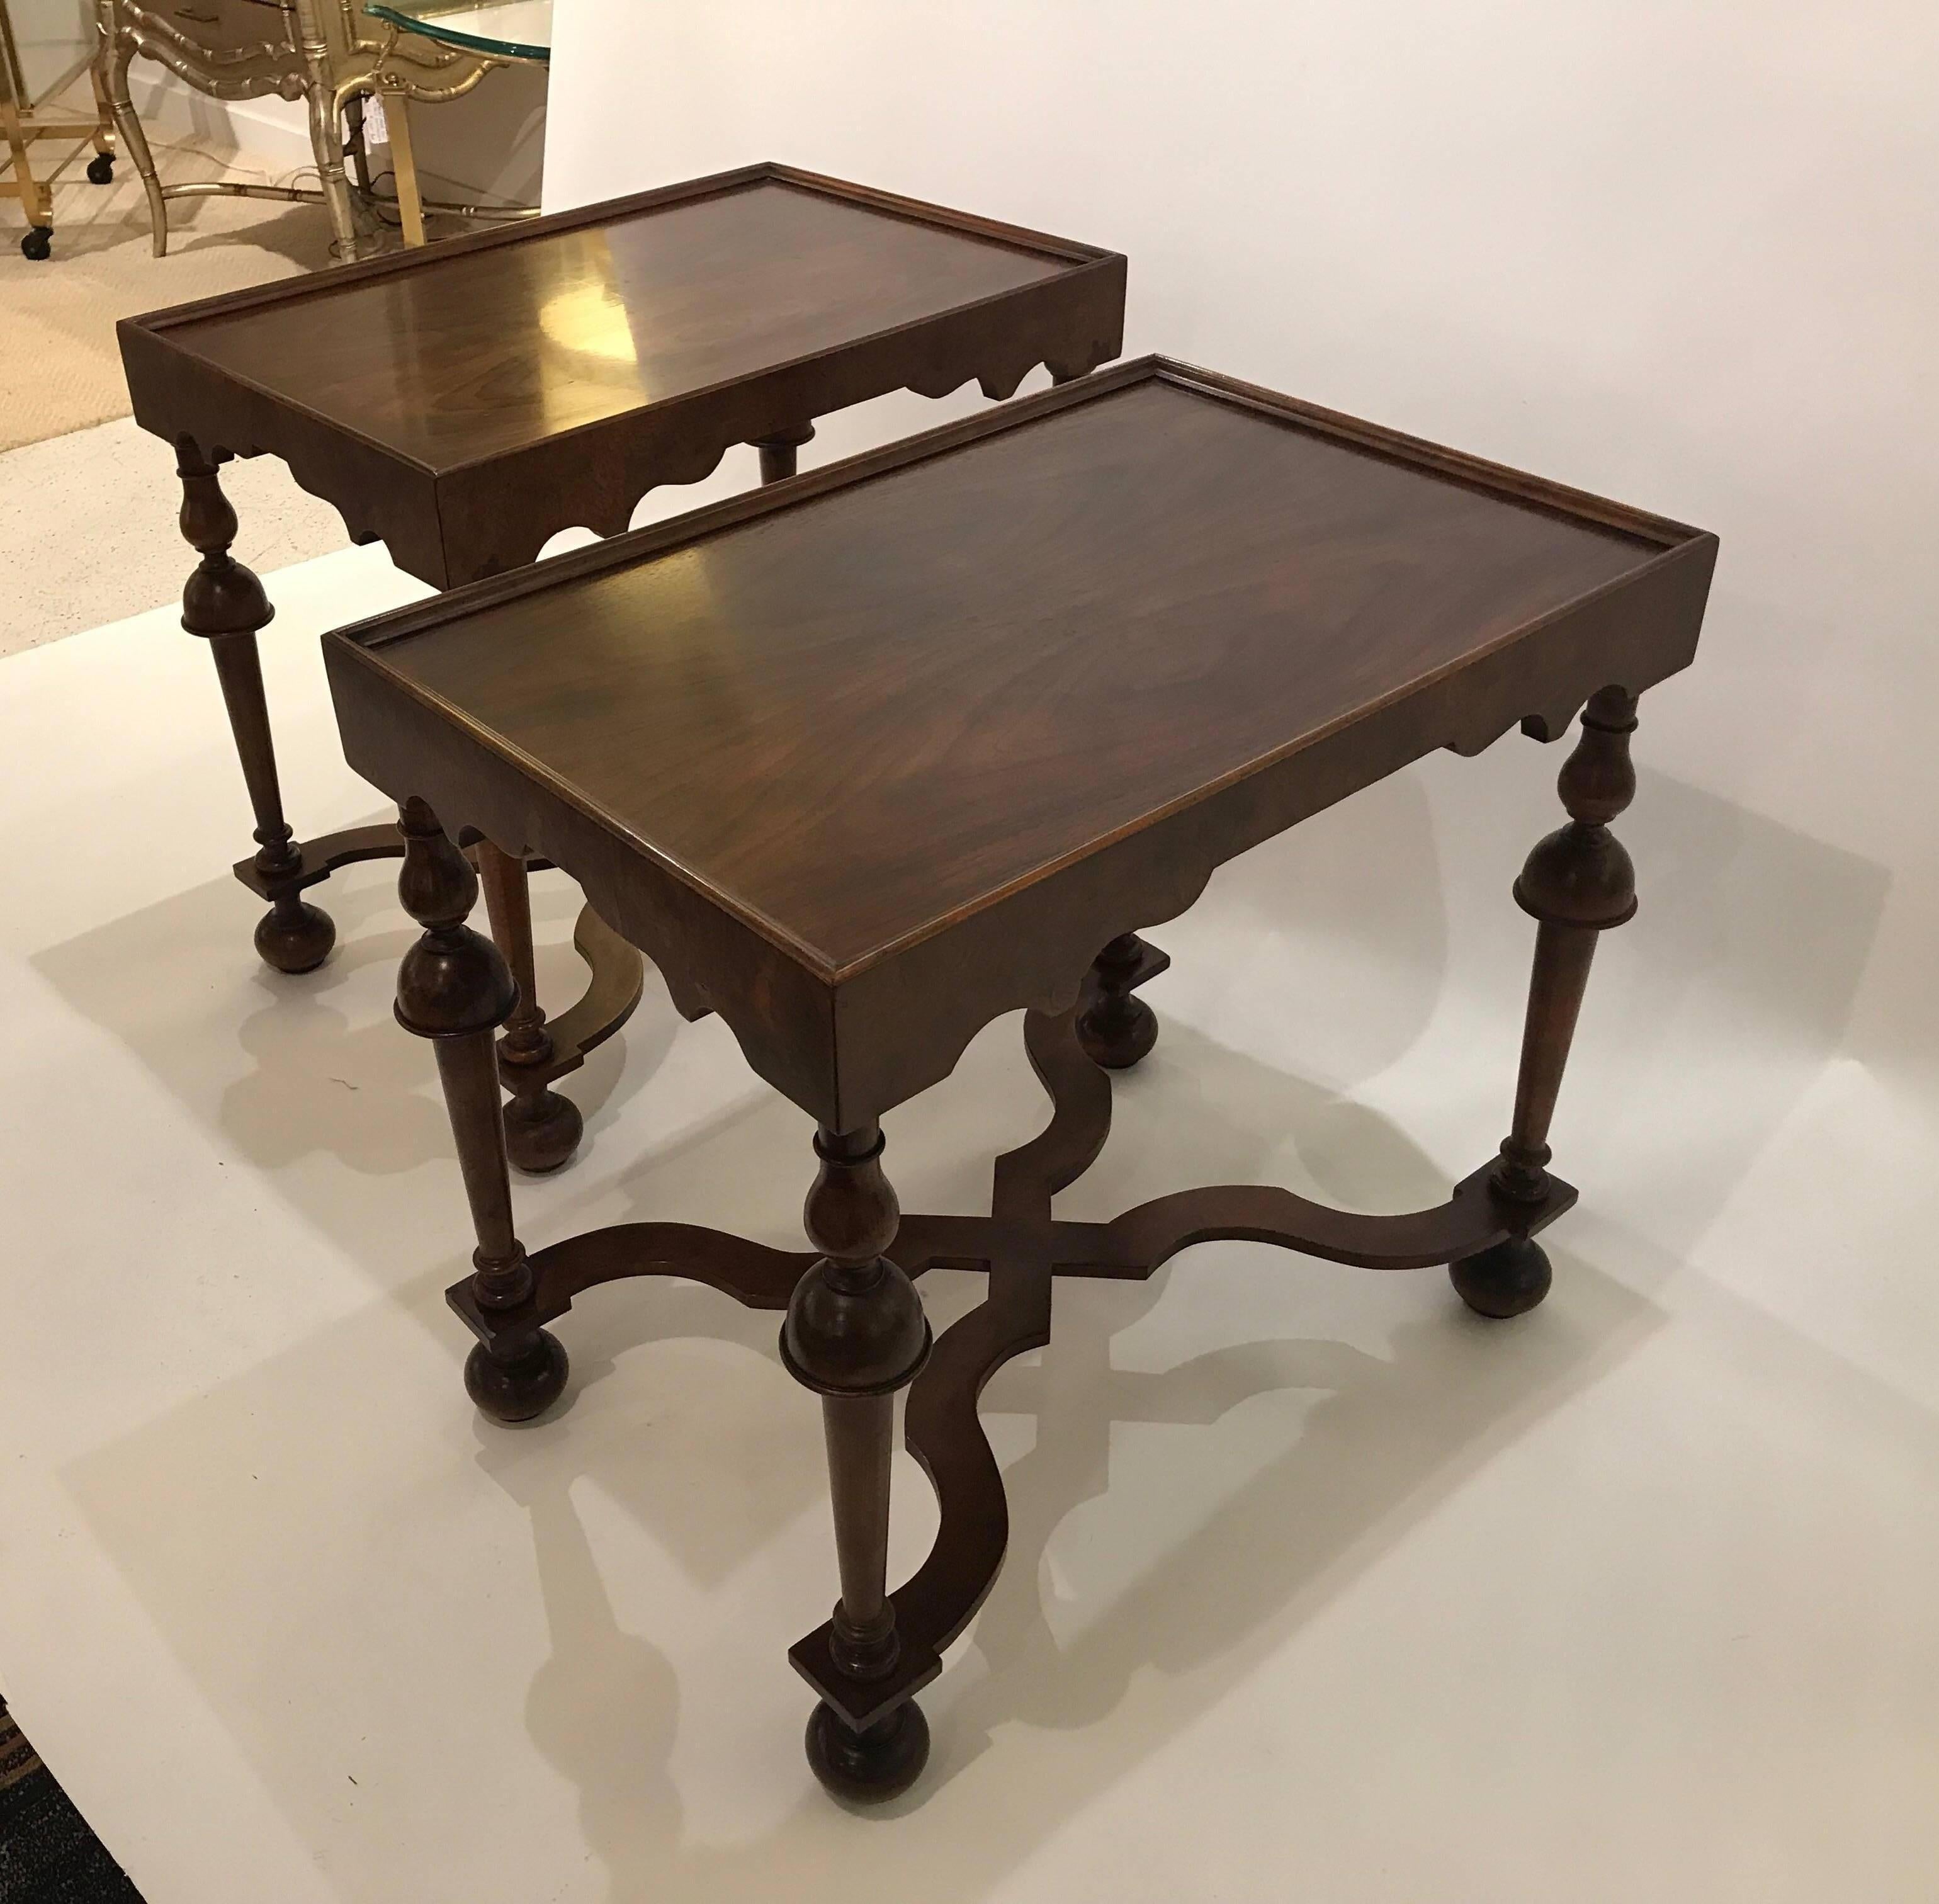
120,165,1124,582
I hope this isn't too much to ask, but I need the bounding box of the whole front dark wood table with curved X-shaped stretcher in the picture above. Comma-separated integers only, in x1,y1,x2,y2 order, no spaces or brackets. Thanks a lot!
325,361,1716,1798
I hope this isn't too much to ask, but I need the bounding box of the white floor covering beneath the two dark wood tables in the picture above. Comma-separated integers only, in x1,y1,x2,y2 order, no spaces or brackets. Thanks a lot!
0,551,1939,1904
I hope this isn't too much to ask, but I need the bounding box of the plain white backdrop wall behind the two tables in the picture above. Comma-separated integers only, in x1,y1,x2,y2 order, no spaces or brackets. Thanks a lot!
547,0,1939,1088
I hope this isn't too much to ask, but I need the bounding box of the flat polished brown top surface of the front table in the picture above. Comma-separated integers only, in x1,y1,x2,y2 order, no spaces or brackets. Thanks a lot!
329,366,1714,975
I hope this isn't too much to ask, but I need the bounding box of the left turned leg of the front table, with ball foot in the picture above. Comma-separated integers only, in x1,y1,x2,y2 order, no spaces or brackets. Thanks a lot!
397,801,566,1421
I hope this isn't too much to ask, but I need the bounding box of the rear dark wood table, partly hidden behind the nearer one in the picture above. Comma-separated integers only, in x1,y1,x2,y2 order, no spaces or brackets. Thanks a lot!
120,165,1124,1171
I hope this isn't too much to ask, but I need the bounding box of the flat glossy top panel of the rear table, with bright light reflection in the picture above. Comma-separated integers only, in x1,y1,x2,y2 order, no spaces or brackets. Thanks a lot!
168,178,1065,469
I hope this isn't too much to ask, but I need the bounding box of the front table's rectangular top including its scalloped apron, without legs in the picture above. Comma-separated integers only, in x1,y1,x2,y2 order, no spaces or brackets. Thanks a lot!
325,359,1716,1128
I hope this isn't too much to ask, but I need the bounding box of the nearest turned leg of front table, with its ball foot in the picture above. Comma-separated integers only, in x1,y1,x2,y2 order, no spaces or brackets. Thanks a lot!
781,1123,929,1799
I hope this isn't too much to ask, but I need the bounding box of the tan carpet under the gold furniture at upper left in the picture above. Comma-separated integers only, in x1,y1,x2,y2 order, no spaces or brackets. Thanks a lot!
0,127,330,450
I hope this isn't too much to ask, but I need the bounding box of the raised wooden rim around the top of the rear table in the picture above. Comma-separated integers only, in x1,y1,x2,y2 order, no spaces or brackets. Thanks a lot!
115,159,1126,483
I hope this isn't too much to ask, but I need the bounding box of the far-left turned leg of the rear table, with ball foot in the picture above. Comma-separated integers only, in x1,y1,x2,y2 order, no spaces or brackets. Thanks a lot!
174,438,337,972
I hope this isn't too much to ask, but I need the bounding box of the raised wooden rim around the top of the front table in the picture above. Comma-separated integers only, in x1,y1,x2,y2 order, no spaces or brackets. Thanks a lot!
324,355,1718,989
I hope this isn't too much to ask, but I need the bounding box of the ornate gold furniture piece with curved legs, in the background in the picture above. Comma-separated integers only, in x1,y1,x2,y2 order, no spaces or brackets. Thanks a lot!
97,0,533,260
